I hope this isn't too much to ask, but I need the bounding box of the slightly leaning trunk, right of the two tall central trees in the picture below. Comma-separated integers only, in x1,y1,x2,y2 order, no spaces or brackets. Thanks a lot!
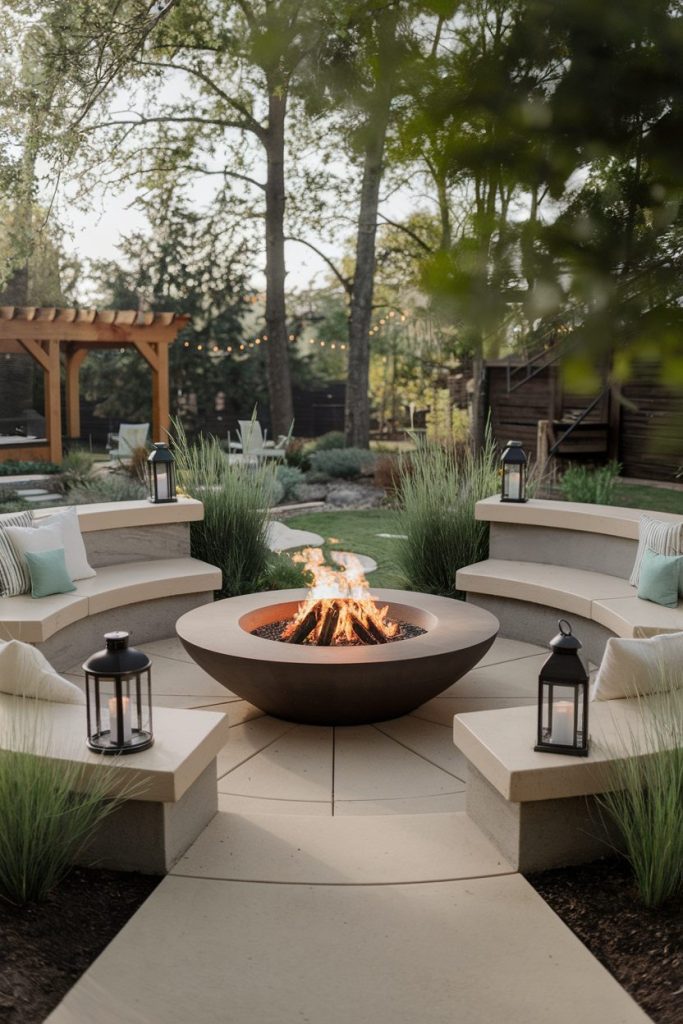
345,100,389,447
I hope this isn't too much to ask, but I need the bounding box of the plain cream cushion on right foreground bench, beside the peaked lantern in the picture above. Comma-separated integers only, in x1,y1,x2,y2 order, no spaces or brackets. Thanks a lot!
591,633,683,700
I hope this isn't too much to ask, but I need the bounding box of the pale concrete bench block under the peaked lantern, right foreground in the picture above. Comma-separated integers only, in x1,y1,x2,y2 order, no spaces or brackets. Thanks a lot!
453,691,683,871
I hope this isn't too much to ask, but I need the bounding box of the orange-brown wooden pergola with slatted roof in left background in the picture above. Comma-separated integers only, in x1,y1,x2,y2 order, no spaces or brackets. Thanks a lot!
0,306,189,462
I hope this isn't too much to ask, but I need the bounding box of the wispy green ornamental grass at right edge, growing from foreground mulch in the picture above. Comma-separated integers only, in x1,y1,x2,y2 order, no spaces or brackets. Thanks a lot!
598,690,683,907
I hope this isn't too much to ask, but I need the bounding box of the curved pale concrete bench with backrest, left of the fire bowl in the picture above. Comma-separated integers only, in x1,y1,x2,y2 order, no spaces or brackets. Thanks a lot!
0,499,221,671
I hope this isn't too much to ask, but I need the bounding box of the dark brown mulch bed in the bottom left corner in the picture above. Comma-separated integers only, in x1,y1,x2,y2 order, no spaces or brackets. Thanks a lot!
0,867,161,1024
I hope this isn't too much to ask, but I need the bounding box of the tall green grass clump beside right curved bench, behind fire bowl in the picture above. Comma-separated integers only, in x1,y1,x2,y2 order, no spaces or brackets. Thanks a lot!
397,434,498,597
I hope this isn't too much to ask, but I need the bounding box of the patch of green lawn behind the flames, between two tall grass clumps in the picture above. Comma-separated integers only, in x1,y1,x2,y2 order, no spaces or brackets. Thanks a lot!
285,509,402,588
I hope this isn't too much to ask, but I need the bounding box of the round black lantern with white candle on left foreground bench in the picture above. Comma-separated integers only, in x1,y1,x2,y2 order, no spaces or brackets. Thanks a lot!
83,630,155,754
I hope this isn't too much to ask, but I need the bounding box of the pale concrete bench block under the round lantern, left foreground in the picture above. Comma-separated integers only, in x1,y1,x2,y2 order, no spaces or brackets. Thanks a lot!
0,684,229,874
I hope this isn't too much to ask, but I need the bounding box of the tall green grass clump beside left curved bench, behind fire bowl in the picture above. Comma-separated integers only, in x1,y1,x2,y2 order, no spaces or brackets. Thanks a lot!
171,421,276,597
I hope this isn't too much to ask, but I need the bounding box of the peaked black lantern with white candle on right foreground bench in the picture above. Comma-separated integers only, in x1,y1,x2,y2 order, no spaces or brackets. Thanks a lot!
533,618,588,758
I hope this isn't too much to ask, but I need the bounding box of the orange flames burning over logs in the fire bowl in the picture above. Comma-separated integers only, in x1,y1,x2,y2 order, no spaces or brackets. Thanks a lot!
281,548,398,645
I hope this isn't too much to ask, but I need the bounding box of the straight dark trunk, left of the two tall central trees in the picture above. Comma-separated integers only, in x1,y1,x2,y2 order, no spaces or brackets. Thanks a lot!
264,89,294,437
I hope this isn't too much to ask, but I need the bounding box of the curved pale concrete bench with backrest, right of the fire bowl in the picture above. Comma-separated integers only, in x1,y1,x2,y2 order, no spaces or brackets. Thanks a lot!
456,497,683,663
